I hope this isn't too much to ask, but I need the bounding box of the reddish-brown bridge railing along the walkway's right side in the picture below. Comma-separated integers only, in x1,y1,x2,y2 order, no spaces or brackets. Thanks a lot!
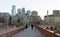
35,25,60,37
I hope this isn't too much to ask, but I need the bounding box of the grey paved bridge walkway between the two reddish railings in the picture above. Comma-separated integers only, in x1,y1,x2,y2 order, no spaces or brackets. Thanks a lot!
14,27,40,37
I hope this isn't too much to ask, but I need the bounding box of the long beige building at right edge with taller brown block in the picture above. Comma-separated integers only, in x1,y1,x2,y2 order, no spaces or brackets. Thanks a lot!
44,10,60,25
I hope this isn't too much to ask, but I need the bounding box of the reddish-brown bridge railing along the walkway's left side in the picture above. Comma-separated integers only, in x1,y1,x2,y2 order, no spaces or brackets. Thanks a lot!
0,26,25,37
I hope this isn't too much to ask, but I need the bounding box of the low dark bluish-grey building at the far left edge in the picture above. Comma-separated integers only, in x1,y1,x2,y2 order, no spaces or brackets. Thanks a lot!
0,12,10,25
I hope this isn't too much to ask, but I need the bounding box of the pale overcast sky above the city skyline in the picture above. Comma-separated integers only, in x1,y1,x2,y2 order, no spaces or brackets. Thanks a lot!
0,0,60,18
